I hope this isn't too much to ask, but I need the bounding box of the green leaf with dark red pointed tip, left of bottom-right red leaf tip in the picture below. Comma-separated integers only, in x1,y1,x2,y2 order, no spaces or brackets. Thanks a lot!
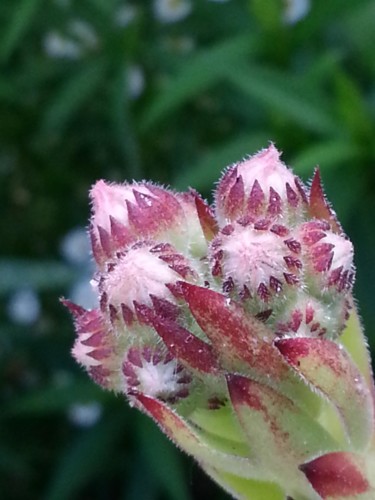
228,375,338,500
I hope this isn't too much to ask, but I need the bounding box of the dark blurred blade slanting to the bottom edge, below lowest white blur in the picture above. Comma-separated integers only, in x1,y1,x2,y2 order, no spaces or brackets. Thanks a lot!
44,410,126,500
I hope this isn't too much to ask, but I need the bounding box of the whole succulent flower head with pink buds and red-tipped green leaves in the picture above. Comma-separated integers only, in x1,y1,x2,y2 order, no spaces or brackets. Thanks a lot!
64,145,375,500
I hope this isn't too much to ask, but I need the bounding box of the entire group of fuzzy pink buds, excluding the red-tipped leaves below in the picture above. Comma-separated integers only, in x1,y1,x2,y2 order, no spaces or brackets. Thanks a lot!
67,145,354,401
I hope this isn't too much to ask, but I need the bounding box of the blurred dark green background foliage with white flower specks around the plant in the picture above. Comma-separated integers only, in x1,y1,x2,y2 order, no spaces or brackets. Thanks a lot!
0,0,375,500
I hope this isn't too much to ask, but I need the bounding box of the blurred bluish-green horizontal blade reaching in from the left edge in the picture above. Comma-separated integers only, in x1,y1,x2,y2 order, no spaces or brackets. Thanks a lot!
0,259,77,296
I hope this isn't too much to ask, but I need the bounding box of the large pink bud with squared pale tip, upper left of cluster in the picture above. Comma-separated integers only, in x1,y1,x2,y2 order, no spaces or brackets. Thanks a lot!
90,181,208,266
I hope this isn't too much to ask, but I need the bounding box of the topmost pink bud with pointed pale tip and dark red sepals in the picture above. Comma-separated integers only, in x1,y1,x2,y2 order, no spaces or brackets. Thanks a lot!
215,144,307,227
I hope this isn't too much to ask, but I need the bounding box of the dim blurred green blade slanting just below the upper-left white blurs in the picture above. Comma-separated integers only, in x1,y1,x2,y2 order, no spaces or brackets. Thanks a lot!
42,59,108,133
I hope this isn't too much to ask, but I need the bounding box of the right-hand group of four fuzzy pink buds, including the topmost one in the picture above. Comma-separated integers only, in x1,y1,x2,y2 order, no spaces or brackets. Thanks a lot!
213,145,354,337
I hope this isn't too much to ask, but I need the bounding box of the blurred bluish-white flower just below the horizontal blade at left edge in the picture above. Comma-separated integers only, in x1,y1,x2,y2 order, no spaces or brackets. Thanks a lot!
7,288,41,325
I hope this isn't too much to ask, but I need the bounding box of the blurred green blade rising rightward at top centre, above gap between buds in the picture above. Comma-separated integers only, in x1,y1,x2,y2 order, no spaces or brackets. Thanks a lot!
141,34,254,130
